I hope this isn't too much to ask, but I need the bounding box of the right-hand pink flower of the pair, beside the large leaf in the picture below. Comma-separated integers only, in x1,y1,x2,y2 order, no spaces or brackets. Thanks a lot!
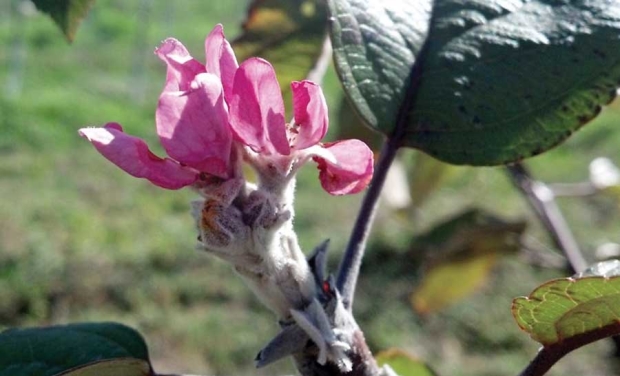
230,58,373,195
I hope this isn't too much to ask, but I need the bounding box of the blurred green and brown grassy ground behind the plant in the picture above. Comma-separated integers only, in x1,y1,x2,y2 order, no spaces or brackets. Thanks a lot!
0,0,620,376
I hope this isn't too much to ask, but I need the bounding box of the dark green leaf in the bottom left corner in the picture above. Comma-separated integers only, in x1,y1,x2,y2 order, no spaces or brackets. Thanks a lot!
0,323,150,376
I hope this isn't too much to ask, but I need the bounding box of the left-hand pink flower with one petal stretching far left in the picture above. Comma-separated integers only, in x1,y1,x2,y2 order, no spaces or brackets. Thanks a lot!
79,25,237,189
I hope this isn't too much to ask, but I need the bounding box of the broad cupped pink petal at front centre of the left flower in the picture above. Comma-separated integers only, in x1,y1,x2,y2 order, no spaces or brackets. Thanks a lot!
155,73,232,178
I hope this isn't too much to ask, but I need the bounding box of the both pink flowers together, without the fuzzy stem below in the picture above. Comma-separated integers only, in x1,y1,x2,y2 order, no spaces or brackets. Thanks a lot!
80,25,373,195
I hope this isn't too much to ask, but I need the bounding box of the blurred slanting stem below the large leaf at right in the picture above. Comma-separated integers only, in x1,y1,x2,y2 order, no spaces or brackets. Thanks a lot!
506,163,588,274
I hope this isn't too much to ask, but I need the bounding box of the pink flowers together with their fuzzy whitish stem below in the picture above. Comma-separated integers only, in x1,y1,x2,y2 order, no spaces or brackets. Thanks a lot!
80,25,373,372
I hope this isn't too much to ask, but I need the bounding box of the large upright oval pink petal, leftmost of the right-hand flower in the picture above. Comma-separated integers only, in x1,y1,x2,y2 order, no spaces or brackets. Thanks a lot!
230,58,291,155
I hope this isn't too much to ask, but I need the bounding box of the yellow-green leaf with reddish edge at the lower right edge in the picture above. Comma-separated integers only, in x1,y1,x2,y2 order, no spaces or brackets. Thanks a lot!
512,260,620,347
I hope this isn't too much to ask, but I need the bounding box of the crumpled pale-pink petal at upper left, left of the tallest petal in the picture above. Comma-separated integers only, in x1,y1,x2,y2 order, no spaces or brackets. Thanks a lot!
155,38,205,91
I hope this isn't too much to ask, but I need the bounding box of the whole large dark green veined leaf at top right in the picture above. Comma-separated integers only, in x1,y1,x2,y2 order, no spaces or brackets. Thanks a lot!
329,0,620,165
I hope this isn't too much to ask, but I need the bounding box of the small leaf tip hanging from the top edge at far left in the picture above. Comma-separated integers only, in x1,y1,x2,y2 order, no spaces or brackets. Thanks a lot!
32,0,95,42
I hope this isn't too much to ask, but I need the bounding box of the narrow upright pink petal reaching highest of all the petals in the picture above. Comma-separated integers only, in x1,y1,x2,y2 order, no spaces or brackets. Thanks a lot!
205,24,239,102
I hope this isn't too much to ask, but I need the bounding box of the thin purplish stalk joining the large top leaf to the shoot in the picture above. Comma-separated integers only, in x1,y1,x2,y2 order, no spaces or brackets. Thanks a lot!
336,138,398,310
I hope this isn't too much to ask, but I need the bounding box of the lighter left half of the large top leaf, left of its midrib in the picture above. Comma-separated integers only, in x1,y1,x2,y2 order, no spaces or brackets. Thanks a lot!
328,0,418,135
